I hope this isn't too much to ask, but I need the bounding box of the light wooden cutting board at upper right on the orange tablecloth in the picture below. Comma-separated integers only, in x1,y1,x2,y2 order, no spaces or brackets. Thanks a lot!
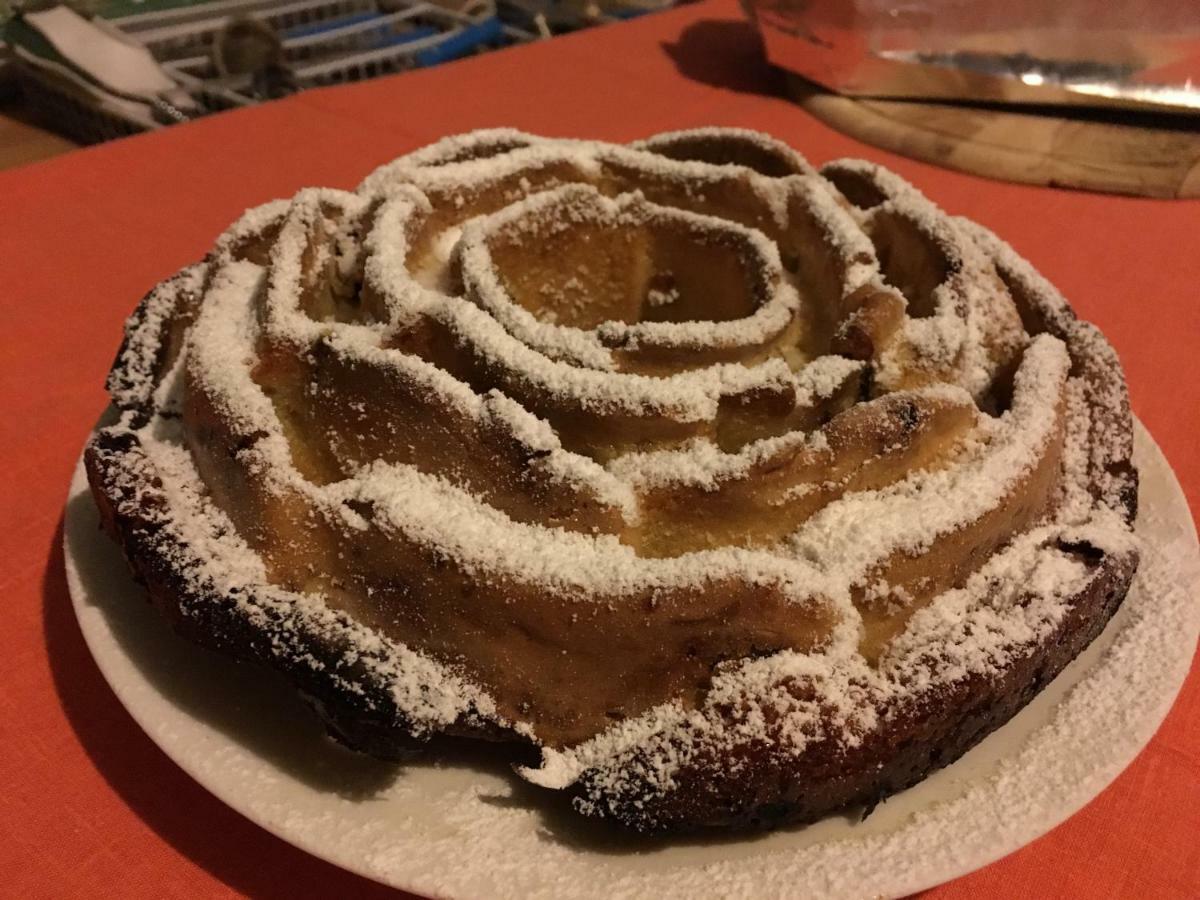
788,74,1200,198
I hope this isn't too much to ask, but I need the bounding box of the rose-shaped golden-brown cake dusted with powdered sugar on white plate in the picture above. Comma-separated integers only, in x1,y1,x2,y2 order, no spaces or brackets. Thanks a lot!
86,128,1136,830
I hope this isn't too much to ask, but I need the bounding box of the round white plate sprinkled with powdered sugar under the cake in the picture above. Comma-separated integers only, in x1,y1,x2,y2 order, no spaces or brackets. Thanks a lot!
65,426,1200,899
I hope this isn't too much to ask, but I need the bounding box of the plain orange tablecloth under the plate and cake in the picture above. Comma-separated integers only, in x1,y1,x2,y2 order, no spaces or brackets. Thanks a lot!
0,0,1200,898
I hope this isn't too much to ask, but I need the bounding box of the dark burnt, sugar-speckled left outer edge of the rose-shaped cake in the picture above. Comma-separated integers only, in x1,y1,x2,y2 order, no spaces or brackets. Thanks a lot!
84,253,529,760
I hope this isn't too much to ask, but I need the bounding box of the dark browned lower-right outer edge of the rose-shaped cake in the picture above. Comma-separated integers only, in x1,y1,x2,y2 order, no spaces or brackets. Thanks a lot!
569,547,1136,834
